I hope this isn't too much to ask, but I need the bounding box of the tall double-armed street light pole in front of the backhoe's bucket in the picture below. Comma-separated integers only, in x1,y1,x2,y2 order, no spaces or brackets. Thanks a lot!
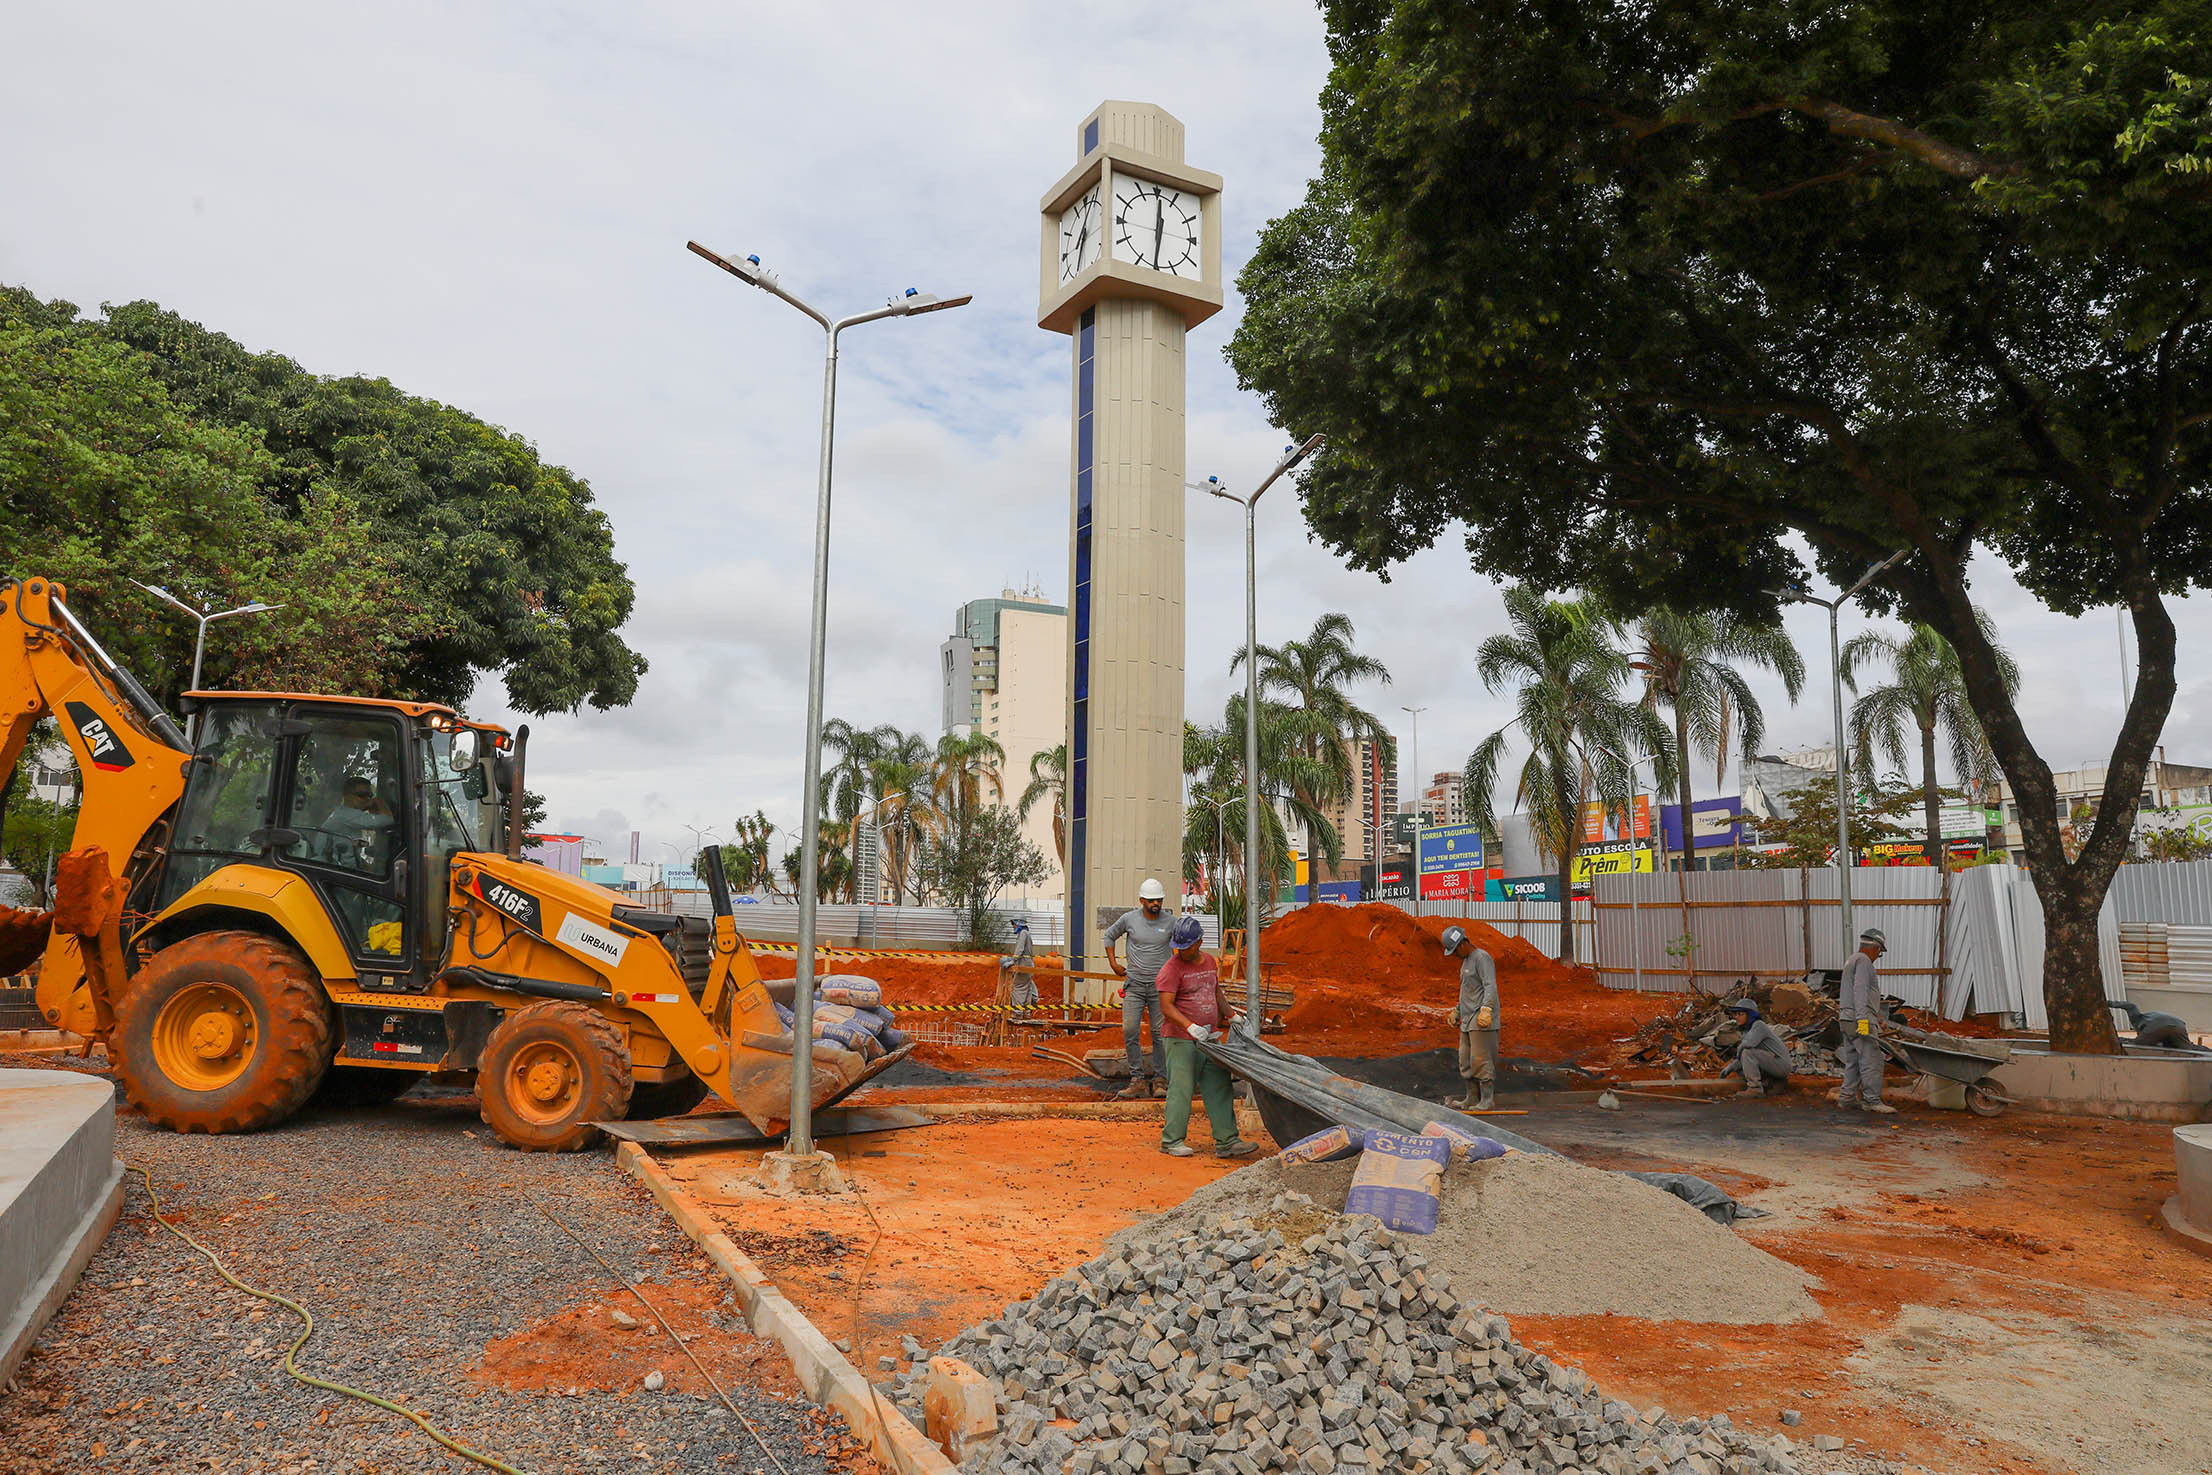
686,241,973,1157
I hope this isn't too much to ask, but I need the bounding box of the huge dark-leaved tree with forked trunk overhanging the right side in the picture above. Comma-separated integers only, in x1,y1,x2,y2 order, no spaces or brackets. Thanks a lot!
1230,0,2212,1050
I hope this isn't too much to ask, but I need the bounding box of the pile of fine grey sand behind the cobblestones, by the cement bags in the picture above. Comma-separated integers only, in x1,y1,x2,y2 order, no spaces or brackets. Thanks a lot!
1113,1152,1820,1325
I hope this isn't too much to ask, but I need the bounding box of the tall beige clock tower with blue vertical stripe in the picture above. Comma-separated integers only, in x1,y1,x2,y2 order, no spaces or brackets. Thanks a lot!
1037,102,1221,981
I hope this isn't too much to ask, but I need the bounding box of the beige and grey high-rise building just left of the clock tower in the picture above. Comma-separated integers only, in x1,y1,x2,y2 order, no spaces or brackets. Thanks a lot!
938,588,1068,900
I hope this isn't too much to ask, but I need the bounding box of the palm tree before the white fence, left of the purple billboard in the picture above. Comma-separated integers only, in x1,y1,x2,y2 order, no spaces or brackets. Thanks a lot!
1462,586,1674,962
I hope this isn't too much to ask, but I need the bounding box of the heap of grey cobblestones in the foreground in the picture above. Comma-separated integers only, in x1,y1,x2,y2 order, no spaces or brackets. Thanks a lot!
887,1192,1796,1475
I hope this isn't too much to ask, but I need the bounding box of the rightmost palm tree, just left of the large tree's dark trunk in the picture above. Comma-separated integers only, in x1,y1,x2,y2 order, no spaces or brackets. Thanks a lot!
1840,608,2020,865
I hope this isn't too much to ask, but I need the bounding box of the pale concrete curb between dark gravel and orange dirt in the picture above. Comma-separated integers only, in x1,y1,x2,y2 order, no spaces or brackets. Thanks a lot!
615,1141,958,1475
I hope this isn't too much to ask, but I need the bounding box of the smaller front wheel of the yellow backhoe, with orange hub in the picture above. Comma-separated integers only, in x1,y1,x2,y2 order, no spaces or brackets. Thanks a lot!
476,1000,633,1152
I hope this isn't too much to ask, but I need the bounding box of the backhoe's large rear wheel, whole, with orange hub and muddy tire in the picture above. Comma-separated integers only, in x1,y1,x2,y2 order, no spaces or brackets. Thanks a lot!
111,931,332,1132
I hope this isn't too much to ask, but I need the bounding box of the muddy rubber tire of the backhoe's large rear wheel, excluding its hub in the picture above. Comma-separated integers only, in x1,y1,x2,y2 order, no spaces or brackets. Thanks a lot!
115,931,332,1132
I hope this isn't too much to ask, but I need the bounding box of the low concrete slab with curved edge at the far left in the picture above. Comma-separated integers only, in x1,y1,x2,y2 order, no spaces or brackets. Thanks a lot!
0,1070,124,1382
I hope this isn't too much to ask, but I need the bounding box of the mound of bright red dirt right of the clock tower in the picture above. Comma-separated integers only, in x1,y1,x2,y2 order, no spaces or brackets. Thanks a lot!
1261,902,1679,1064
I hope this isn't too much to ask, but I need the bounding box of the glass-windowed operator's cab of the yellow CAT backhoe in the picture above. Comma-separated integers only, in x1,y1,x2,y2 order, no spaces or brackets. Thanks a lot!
148,692,513,993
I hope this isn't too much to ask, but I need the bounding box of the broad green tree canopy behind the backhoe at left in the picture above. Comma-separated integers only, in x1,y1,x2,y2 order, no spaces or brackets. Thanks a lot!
0,287,646,712
